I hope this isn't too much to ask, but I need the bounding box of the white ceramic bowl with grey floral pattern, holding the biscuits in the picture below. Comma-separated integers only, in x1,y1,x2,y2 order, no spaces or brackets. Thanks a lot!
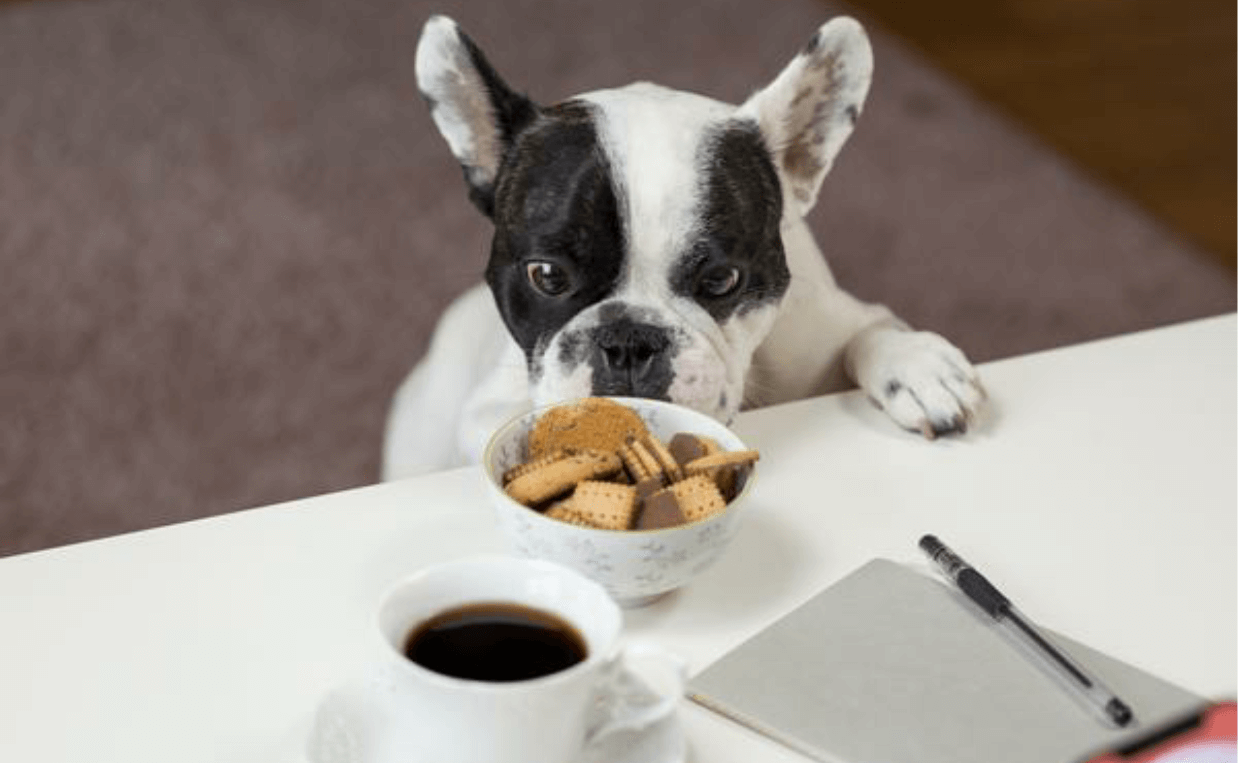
482,398,759,607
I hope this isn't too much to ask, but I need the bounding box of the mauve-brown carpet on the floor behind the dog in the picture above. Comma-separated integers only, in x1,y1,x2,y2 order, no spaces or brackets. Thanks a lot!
0,0,1236,555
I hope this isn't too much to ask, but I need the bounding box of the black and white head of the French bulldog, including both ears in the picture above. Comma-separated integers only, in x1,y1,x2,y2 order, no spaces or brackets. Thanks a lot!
416,16,872,420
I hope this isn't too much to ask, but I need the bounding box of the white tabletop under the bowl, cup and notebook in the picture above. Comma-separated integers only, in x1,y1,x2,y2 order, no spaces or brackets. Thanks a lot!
0,315,1238,763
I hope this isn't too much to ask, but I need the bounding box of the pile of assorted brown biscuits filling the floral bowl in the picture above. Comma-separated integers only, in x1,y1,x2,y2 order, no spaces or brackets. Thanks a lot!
503,398,758,530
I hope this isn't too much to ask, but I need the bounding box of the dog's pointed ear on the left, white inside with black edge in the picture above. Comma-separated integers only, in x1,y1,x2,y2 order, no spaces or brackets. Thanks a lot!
416,16,537,217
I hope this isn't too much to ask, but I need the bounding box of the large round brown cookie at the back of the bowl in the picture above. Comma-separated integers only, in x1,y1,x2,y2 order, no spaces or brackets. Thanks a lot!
529,398,649,458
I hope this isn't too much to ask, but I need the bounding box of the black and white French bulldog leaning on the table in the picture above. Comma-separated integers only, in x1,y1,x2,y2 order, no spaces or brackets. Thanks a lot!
384,16,984,478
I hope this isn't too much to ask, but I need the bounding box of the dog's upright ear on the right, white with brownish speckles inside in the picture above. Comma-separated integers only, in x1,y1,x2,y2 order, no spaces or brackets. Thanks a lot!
737,16,873,214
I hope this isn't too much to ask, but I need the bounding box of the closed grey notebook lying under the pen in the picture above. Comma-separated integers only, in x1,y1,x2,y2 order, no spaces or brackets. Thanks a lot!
688,560,1200,763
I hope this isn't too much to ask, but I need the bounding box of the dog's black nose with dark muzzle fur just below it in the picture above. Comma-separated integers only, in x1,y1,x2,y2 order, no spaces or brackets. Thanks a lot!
593,320,671,398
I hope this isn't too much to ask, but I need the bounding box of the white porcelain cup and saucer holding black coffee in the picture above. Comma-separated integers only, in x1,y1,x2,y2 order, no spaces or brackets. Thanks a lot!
307,556,685,763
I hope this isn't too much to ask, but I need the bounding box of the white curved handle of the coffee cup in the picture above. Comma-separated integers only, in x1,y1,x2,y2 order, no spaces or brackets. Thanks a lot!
587,642,687,743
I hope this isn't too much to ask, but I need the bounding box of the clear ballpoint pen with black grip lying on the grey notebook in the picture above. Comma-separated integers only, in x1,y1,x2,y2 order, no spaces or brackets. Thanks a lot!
920,535,1135,726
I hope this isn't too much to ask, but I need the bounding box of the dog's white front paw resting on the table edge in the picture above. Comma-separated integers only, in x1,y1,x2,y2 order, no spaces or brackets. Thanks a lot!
849,328,985,440
